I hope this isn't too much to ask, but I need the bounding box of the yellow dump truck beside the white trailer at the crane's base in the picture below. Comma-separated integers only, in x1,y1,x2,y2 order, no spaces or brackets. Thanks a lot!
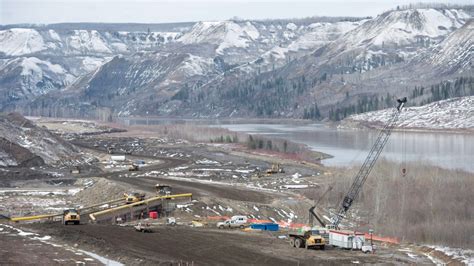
288,228,327,249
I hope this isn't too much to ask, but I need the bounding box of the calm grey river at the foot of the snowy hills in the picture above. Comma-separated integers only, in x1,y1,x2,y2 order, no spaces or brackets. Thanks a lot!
118,119,474,172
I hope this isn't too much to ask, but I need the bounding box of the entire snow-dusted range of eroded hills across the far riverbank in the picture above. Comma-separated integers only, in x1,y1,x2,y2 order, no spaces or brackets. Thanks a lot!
0,6,474,120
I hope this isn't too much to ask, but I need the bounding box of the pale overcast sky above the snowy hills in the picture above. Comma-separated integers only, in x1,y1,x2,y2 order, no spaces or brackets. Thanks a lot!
0,0,474,24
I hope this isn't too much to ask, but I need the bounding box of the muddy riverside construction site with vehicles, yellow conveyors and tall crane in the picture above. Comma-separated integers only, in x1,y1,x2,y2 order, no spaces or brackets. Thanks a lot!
0,98,472,265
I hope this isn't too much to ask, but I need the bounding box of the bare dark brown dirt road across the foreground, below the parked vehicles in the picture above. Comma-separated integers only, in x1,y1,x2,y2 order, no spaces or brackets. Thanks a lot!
23,224,428,265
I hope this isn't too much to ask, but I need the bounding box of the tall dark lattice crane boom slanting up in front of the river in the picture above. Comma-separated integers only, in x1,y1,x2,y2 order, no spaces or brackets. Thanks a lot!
331,97,407,228
